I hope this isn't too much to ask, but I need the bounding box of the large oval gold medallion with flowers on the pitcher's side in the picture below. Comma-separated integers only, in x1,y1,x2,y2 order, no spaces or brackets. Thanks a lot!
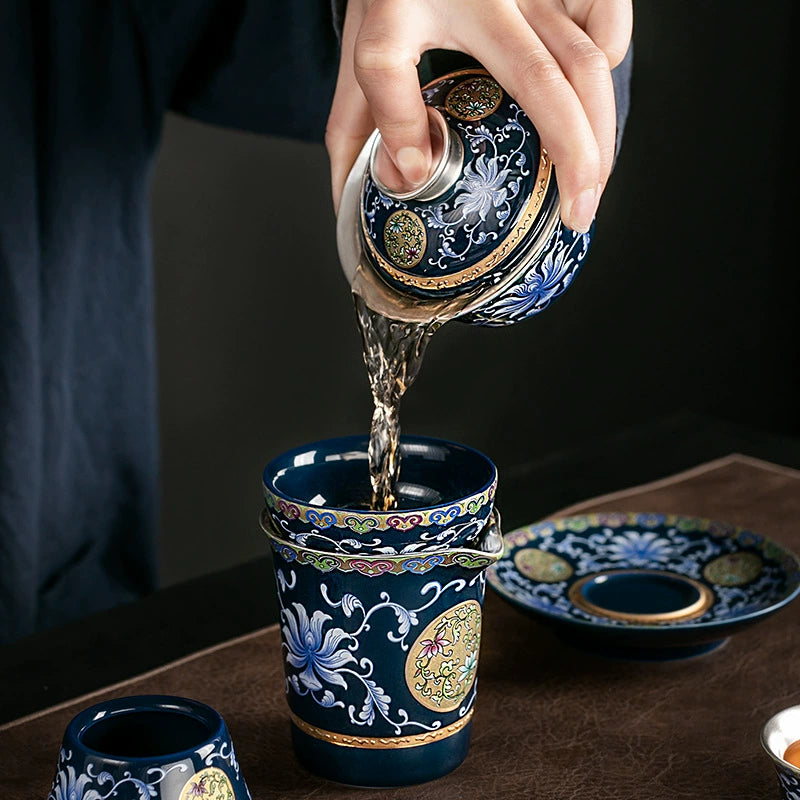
406,600,481,712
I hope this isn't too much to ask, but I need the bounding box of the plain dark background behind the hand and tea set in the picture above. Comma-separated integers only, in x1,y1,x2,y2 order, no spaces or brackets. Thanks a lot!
148,0,800,584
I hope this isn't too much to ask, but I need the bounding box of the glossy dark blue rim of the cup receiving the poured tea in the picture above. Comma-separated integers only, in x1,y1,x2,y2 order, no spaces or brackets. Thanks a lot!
262,434,497,519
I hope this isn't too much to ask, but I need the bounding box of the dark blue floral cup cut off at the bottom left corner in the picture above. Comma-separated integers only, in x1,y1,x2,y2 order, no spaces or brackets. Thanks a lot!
48,695,250,800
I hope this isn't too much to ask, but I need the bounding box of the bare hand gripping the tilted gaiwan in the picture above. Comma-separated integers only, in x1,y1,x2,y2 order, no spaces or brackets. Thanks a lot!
325,0,633,232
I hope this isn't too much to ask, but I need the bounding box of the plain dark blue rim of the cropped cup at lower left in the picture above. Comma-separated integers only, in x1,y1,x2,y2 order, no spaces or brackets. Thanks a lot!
64,695,228,765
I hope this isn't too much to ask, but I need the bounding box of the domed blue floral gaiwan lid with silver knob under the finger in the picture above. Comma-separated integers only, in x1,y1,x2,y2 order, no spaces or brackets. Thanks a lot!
360,67,558,299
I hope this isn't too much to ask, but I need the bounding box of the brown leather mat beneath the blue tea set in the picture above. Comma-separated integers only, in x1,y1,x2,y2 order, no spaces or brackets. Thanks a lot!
0,457,800,800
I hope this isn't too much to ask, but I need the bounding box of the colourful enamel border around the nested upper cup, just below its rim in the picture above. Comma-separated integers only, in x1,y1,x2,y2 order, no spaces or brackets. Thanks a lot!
264,478,497,534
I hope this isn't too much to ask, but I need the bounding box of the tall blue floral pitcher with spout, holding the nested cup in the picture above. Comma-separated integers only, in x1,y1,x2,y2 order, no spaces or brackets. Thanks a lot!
262,509,503,786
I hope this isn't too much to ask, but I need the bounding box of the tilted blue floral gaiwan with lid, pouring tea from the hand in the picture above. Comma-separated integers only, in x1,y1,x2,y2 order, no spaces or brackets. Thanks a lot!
337,61,593,326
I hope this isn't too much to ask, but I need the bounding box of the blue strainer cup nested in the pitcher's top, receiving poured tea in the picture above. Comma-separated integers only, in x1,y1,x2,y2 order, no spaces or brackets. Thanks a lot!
263,436,497,555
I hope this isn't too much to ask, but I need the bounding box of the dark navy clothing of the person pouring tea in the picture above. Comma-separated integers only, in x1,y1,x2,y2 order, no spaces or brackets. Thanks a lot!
0,0,338,642
